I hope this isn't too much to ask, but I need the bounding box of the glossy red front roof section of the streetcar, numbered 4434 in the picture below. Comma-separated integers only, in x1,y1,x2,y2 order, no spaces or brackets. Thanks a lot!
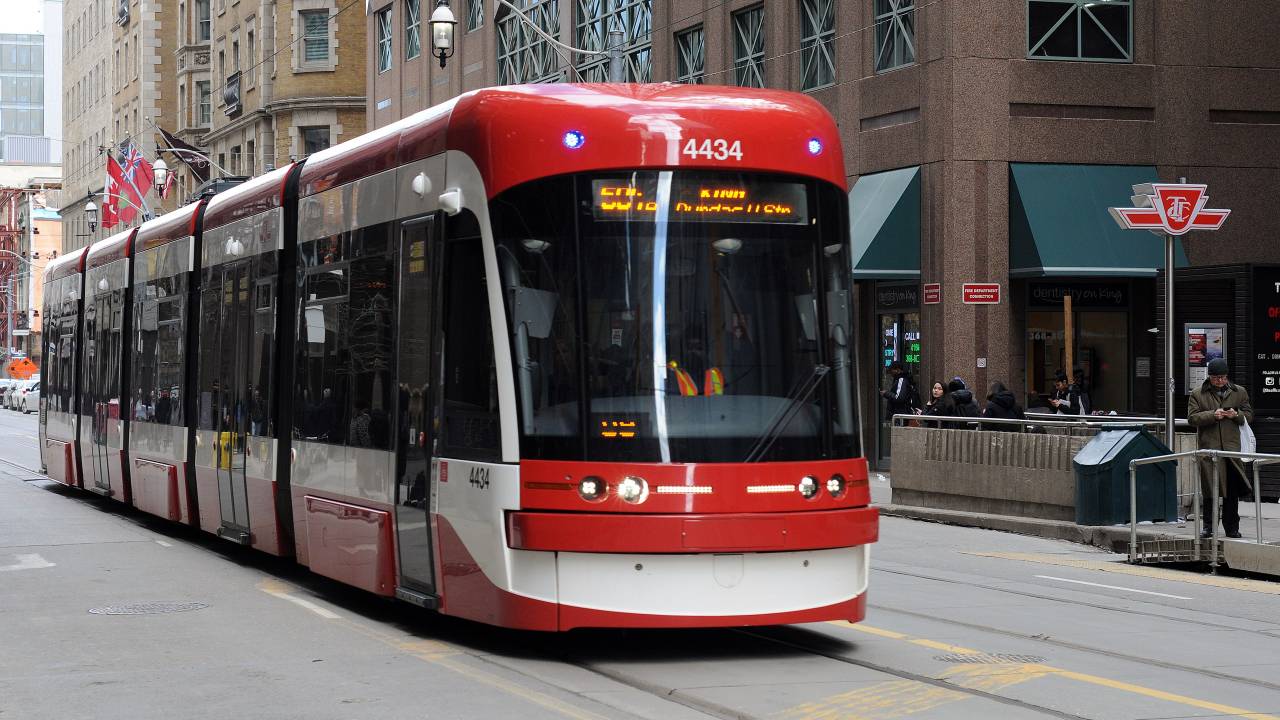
298,83,847,196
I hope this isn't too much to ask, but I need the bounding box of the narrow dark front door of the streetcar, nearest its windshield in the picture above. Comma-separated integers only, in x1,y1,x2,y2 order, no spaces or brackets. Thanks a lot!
396,217,436,603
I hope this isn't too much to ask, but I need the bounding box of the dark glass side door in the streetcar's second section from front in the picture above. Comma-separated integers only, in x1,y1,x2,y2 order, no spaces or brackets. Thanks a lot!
214,261,253,542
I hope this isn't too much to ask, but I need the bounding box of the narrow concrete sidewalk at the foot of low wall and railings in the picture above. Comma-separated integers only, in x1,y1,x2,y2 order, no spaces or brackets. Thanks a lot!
870,470,1280,578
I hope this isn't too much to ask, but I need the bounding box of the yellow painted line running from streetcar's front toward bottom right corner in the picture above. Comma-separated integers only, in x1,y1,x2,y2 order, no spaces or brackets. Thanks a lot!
829,621,1280,720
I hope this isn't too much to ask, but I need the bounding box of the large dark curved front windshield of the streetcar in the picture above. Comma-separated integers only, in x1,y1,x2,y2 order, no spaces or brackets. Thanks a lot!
492,170,858,462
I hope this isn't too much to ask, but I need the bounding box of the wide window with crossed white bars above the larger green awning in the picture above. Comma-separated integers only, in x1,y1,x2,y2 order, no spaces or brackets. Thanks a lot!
1027,0,1133,63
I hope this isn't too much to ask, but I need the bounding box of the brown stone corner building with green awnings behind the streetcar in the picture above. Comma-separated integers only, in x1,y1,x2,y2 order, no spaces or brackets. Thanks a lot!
367,0,1280,466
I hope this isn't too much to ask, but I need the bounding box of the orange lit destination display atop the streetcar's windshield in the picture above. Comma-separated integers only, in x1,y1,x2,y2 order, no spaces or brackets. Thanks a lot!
591,176,809,225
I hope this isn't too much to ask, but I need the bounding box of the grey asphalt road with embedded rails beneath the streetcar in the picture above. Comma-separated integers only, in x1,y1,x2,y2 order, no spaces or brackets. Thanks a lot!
0,411,1280,720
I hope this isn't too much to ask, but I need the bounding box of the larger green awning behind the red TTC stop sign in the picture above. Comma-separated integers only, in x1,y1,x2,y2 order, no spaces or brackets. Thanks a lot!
1009,163,1188,278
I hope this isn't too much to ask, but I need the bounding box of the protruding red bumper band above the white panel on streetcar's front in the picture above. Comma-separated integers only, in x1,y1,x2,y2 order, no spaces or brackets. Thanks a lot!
507,507,879,553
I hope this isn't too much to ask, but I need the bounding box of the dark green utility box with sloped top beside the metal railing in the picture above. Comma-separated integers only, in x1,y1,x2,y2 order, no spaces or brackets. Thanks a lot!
1071,427,1178,525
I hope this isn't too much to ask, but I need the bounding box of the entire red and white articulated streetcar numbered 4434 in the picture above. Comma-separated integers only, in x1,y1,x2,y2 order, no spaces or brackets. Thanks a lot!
41,85,878,630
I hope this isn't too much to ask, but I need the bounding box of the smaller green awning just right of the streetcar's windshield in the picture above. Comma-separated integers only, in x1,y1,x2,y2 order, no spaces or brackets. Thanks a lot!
849,168,920,279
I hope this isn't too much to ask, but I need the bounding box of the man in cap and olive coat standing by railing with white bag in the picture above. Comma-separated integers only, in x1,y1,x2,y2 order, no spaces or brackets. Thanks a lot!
1187,357,1253,538
